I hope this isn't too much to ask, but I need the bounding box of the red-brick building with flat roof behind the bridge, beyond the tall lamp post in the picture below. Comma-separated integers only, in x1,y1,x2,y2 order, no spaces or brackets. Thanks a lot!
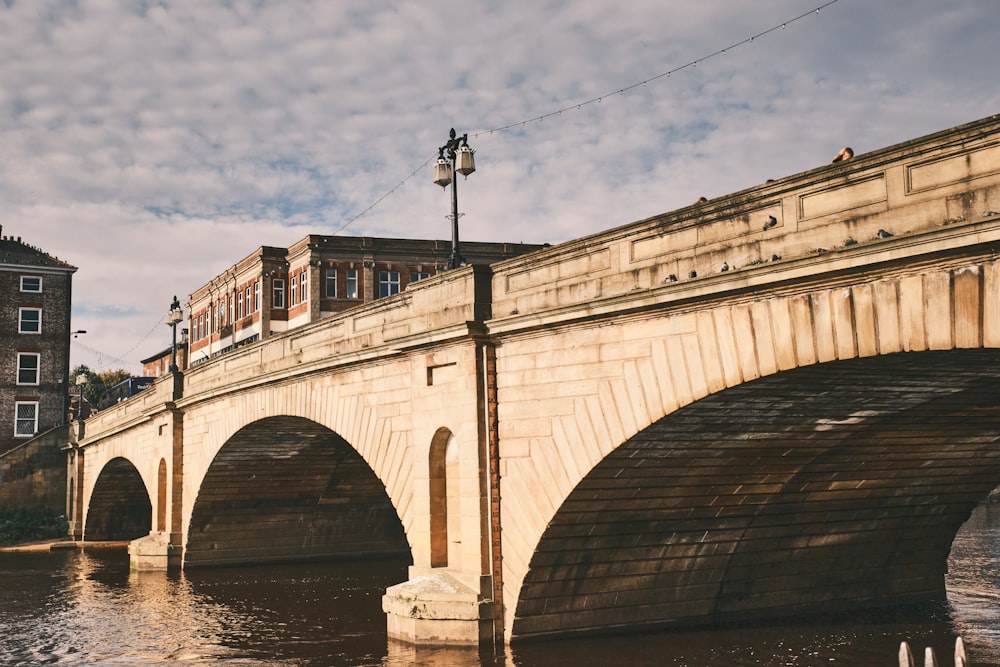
186,234,544,366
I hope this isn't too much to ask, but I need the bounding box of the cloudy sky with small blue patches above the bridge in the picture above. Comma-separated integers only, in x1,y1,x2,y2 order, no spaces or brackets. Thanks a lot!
0,0,1000,374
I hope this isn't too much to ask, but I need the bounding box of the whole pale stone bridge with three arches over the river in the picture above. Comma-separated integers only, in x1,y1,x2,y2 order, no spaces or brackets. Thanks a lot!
68,116,1000,644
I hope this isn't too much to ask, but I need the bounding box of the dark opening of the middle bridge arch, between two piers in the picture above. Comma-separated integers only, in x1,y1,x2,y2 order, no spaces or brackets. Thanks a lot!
184,416,410,567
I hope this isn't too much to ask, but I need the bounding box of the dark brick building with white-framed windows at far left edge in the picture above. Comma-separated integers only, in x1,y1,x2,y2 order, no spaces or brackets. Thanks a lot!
0,227,76,454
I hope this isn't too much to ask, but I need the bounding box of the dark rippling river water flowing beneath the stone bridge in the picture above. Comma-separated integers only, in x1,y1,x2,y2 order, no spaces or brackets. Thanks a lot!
0,505,1000,667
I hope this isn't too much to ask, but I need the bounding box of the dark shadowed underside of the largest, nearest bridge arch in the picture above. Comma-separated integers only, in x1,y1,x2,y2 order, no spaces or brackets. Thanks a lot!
513,350,1000,636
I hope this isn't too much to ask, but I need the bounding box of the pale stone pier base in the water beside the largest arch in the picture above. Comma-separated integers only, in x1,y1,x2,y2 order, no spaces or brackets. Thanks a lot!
382,572,493,646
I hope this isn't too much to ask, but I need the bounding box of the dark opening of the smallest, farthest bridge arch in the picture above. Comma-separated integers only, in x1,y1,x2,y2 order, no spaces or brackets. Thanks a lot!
83,456,153,541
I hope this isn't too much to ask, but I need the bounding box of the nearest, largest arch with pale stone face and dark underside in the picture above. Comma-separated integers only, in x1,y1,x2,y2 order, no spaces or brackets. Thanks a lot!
498,260,1000,639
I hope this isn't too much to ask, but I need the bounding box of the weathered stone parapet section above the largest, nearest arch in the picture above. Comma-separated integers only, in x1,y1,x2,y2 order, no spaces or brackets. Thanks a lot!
490,116,1000,332
